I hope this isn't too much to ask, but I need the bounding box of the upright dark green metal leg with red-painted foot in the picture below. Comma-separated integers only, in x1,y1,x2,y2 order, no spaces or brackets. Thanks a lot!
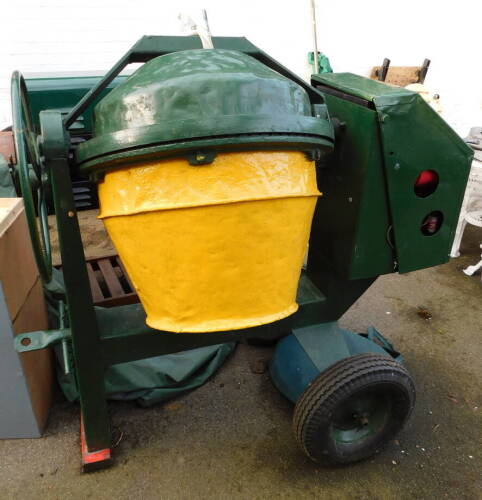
41,112,110,470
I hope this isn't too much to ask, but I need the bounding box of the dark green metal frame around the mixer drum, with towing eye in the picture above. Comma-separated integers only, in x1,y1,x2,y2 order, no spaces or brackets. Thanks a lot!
9,37,371,468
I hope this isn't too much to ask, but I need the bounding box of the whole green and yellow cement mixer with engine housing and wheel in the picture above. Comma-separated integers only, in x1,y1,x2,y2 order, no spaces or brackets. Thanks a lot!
7,36,471,471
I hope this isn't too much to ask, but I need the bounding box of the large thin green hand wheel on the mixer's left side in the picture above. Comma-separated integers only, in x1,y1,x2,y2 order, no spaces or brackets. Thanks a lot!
11,71,52,284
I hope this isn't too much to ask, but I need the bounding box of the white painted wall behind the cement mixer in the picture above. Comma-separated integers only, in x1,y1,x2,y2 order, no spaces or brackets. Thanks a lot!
0,0,482,136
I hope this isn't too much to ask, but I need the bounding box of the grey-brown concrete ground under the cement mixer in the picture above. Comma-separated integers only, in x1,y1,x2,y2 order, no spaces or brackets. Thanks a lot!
0,229,482,500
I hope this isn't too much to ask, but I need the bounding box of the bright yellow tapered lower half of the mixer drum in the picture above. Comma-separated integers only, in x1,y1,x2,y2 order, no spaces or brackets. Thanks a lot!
99,151,320,332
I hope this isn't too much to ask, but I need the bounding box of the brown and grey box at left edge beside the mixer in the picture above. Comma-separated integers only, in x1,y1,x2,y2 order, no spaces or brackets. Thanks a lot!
0,198,53,438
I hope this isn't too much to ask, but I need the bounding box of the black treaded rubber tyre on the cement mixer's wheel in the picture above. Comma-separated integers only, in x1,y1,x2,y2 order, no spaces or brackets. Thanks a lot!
293,354,415,465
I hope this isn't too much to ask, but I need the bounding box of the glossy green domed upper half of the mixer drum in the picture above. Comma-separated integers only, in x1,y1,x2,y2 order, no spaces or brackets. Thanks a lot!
77,49,333,172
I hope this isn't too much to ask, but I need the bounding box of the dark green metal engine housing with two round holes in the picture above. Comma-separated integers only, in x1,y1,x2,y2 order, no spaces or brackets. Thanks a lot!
310,73,473,279
